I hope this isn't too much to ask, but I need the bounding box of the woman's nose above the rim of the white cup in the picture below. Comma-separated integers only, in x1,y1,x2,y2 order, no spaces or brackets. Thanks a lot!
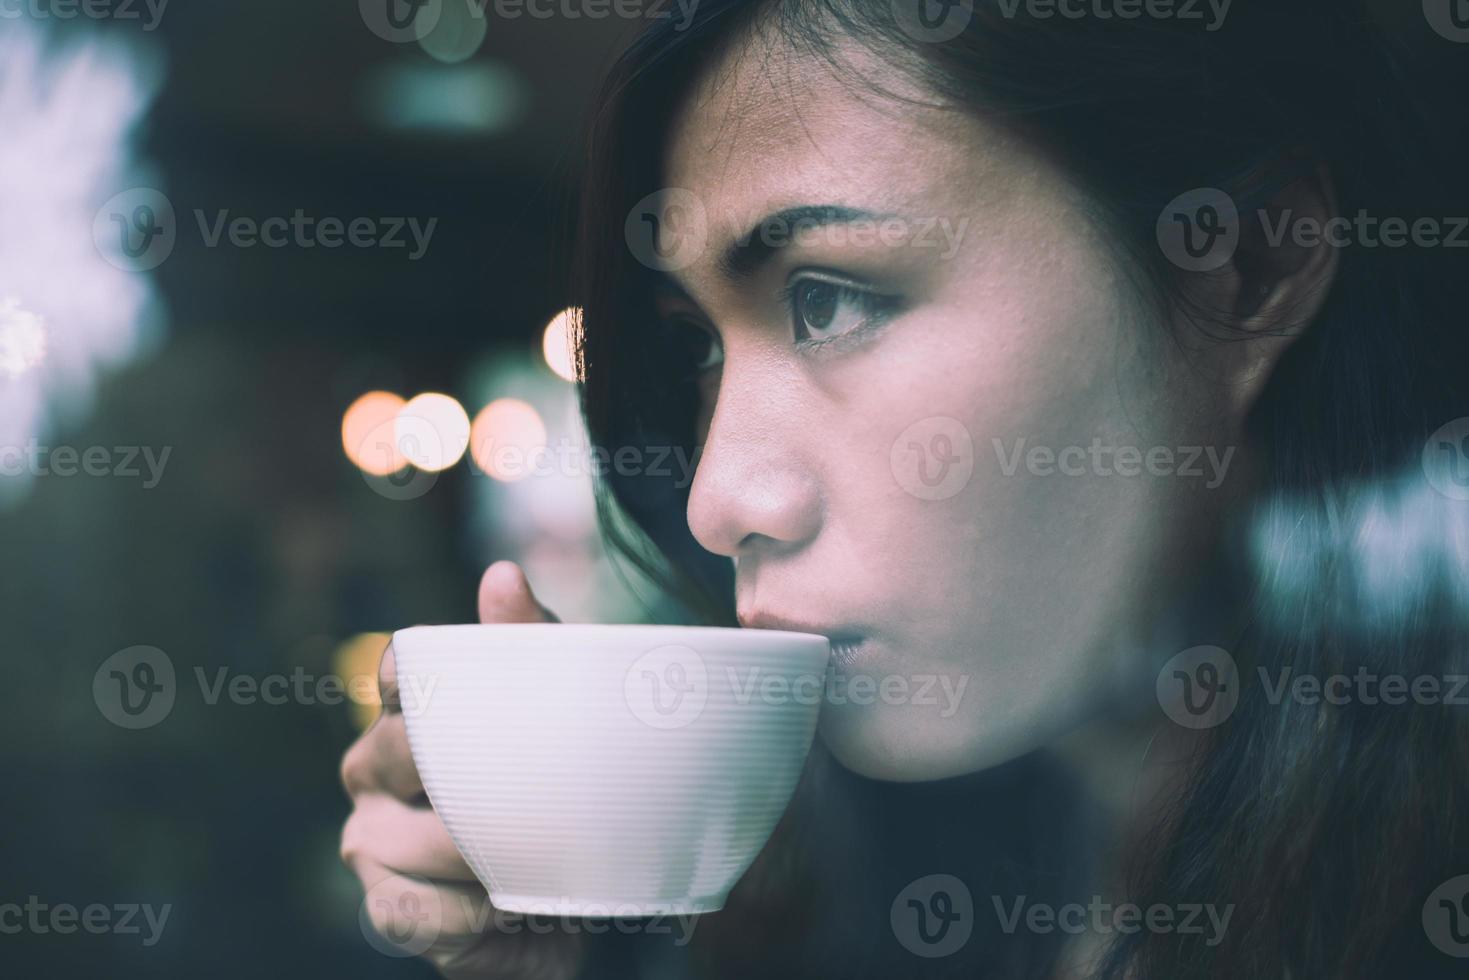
689,359,823,558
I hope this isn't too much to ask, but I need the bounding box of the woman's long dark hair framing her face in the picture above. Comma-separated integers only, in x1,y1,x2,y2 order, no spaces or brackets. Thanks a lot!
576,0,1469,980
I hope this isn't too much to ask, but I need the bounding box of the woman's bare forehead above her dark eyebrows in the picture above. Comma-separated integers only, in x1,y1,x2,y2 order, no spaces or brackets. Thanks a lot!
663,26,1025,273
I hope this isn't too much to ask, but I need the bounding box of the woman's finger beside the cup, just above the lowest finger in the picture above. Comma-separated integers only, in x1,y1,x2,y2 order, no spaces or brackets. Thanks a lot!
342,796,477,883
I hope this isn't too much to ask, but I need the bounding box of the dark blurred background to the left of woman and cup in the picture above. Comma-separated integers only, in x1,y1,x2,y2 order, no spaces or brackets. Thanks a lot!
0,0,655,977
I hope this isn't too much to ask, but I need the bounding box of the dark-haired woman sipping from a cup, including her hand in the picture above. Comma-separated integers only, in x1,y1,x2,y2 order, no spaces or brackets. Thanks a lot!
344,0,1469,980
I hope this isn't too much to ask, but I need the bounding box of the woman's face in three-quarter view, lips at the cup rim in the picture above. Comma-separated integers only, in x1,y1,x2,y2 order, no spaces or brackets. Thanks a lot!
658,32,1241,779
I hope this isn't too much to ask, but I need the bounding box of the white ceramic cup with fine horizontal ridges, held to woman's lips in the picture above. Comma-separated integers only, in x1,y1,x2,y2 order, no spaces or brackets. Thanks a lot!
392,623,829,917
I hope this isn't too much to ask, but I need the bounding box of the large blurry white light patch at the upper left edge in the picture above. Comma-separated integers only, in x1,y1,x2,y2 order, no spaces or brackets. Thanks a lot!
0,18,162,498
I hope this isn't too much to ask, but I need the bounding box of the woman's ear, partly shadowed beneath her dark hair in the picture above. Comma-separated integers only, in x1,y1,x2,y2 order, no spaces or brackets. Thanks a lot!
1178,166,1343,423
